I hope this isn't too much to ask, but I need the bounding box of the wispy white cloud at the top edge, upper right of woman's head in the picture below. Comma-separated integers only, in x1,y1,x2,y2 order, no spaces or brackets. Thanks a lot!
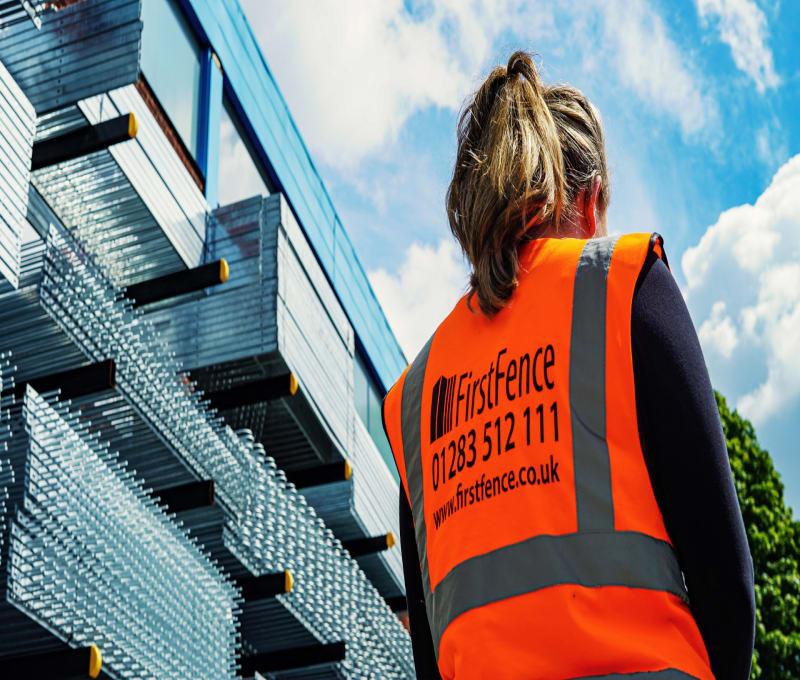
588,0,717,135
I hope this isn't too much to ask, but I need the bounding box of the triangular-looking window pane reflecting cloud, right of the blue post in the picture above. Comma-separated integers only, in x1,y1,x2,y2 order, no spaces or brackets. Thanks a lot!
217,97,270,205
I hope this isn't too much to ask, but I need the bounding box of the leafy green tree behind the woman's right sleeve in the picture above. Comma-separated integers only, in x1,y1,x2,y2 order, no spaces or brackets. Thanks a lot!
716,394,800,680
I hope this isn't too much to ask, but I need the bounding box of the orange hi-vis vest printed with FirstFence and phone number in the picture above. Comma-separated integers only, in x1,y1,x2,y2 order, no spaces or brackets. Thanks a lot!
383,234,714,680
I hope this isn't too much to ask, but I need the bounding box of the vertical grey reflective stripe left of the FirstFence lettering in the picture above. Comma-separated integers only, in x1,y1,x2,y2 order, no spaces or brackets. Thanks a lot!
400,336,433,630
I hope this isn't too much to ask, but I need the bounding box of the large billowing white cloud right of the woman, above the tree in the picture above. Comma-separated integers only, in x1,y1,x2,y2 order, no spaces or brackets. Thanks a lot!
682,155,800,424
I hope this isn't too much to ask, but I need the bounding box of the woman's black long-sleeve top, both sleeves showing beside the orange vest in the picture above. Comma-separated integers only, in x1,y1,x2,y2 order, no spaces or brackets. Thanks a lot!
400,253,755,680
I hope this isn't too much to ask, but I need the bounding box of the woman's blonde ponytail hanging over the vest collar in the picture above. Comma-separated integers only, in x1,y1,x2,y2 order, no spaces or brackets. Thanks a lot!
447,51,565,317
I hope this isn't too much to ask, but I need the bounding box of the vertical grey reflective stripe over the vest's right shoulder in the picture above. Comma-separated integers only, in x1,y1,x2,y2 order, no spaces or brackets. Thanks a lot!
569,237,617,532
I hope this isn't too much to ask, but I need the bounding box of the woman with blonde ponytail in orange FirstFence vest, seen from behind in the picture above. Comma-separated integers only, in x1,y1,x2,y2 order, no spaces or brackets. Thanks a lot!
384,52,754,680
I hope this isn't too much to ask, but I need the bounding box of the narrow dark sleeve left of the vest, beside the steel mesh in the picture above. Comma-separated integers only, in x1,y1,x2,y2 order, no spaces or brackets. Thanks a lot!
400,487,441,680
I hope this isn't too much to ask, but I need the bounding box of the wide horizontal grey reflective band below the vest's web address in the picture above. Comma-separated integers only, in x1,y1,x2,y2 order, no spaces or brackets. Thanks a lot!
431,531,687,650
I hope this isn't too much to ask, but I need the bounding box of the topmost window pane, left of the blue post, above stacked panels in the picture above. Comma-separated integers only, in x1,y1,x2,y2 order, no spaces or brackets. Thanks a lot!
142,0,200,157
